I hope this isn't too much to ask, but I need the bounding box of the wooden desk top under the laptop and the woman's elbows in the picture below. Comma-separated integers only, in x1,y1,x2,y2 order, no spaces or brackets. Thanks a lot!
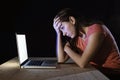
0,58,109,80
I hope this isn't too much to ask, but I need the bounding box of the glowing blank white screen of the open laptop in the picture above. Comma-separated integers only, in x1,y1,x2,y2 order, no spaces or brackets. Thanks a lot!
16,34,28,64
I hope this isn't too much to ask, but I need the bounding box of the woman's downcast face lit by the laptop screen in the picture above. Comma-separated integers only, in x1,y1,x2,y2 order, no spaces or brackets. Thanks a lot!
60,21,76,38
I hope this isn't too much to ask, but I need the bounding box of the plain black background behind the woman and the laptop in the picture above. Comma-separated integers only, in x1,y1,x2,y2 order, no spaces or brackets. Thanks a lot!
0,0,120,64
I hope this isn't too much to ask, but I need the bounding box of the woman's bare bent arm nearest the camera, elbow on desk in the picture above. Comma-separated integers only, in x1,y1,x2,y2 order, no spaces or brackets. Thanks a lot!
64,32,104,68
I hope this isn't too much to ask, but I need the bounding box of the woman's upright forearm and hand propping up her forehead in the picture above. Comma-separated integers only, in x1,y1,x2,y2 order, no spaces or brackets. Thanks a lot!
53,18,68,63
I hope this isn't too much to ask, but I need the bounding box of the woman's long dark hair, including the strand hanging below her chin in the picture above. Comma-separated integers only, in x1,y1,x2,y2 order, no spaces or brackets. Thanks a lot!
55,8,103,52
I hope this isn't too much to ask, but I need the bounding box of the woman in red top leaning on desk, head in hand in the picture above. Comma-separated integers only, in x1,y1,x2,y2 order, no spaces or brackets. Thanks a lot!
53,8,120,79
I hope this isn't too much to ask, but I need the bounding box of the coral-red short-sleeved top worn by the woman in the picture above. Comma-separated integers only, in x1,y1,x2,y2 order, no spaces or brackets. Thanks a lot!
77,24,120,69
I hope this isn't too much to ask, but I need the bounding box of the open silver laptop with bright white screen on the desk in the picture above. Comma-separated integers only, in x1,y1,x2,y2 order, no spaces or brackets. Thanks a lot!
15,33,57,68
